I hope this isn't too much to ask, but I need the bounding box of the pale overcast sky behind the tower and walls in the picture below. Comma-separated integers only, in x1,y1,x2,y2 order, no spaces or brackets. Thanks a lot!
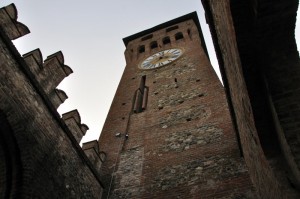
0,0,300,142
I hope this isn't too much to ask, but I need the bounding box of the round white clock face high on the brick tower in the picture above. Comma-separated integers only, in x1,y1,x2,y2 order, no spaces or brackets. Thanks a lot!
139,48,183,69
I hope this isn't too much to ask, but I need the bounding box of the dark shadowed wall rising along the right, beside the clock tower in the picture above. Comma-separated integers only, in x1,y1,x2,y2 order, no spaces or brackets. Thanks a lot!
202,0,299,198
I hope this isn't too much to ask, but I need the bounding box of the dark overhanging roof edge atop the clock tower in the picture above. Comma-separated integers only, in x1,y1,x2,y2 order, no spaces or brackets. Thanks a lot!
123,11,208,56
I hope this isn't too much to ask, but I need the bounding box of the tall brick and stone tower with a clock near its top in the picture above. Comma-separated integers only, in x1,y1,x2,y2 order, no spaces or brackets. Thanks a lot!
99,13,256,199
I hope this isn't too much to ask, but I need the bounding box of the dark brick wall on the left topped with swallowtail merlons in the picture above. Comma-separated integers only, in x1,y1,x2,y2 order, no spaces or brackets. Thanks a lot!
0,4,103,198
